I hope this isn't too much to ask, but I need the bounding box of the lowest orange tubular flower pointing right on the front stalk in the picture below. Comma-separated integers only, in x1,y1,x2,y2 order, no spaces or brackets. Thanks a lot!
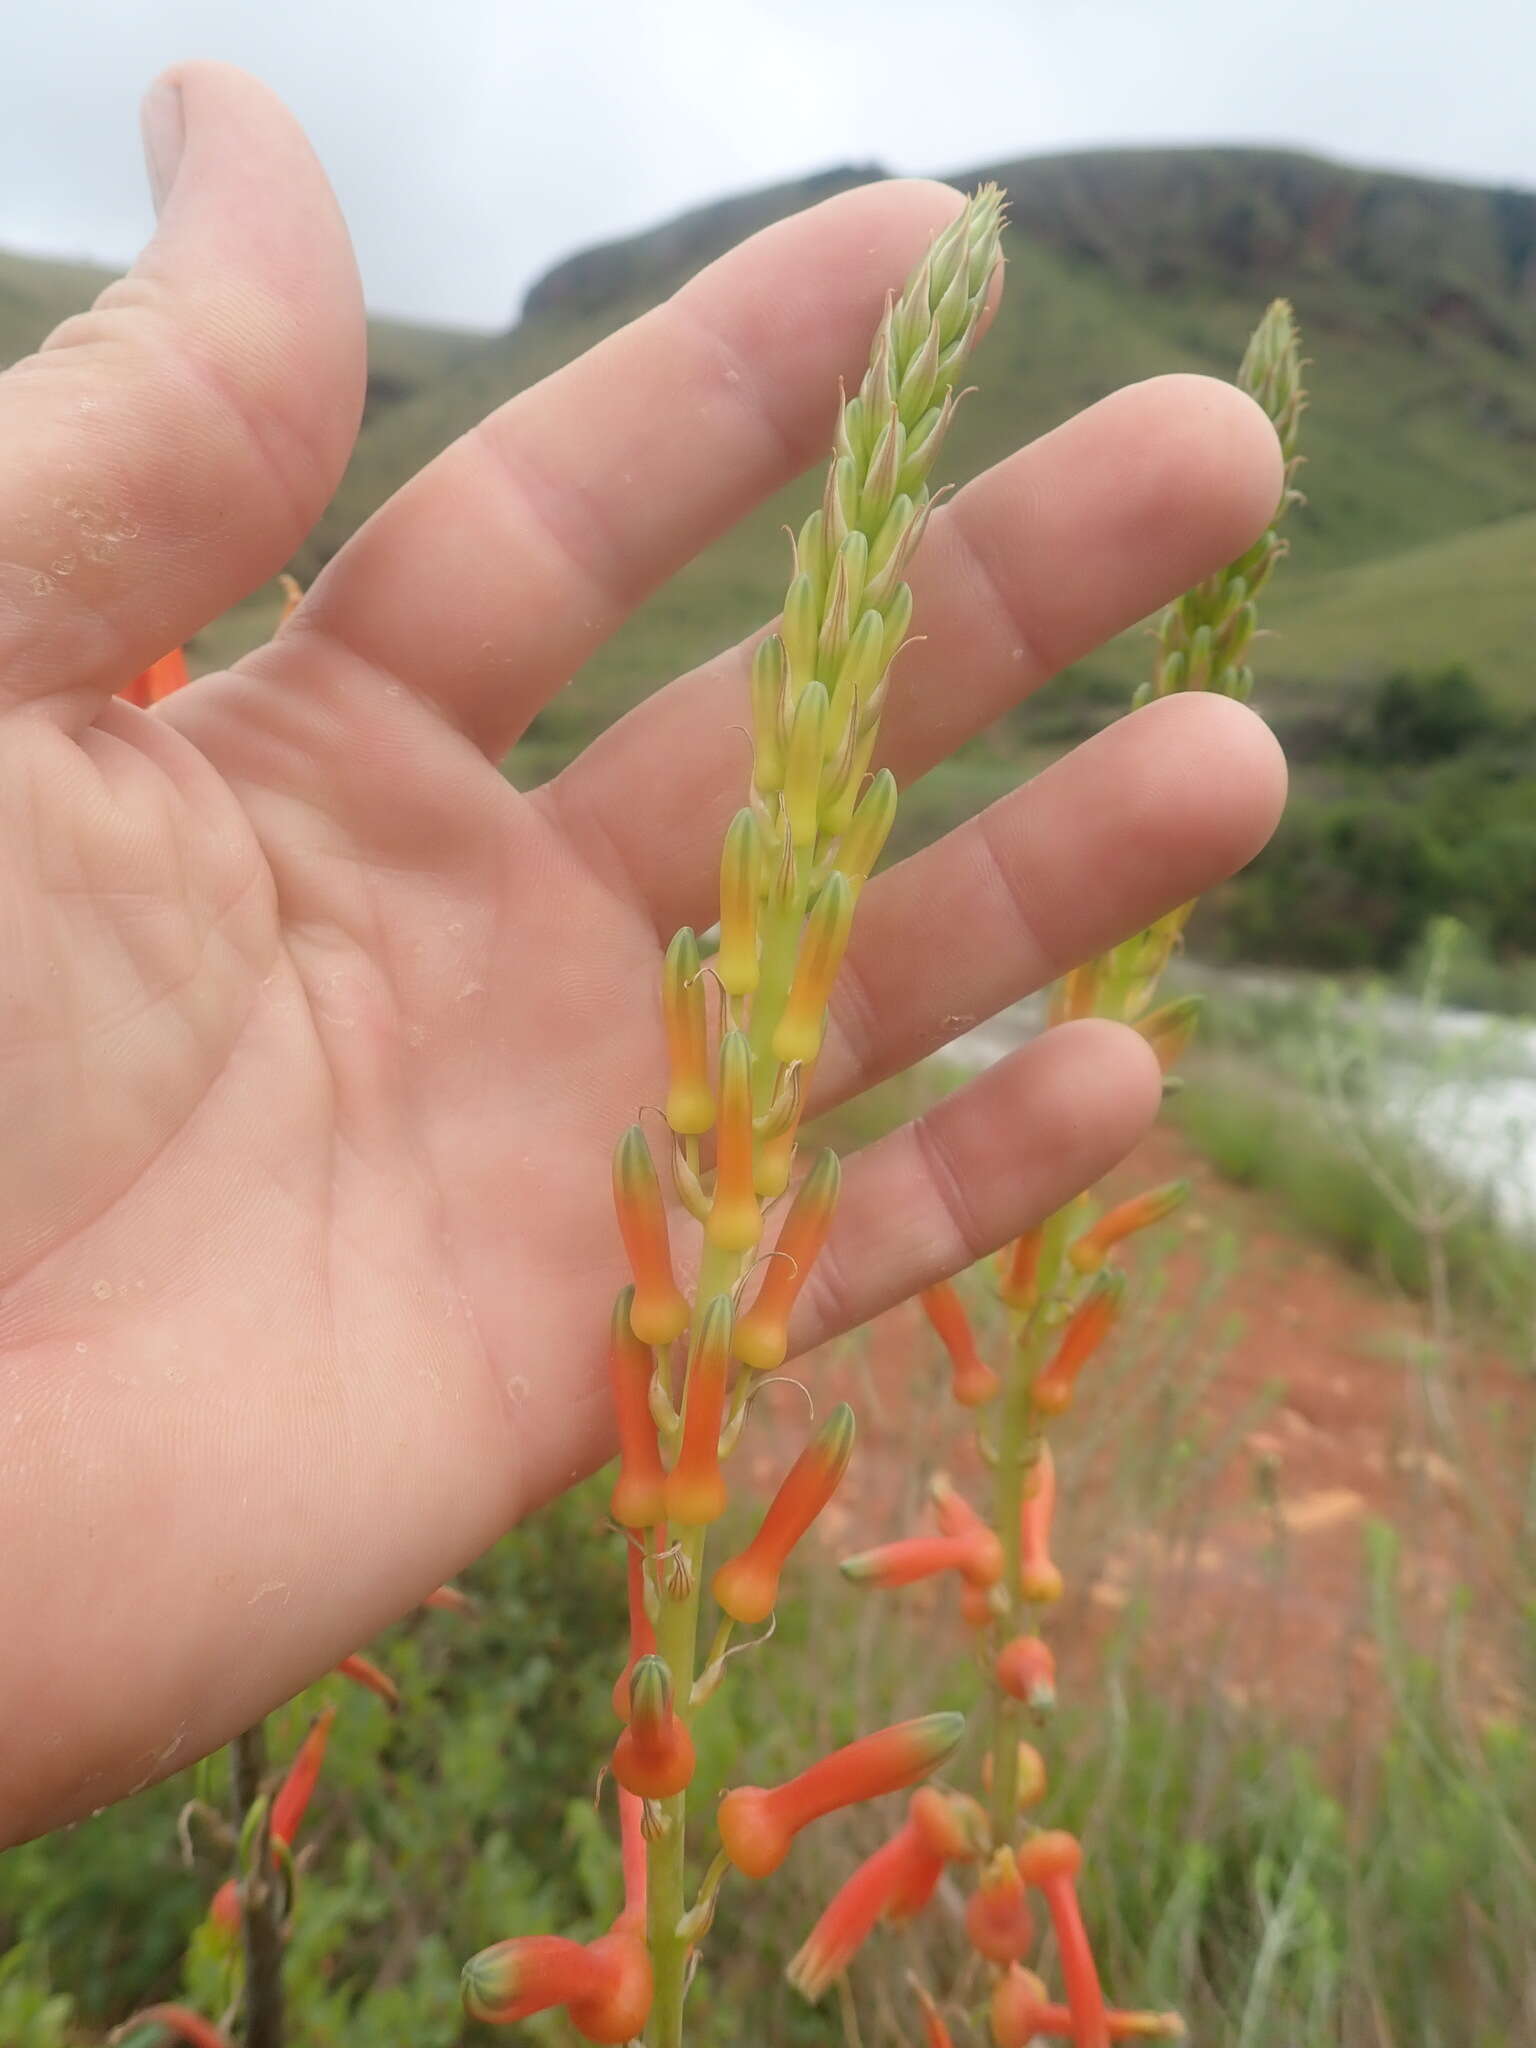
719,1714,965,1878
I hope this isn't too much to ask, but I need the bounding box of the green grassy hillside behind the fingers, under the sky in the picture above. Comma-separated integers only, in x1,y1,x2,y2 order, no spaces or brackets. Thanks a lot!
0,150,1536,974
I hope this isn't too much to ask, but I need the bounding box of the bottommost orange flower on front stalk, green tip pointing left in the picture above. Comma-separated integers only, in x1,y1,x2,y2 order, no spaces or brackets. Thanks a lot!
463,1927,651,2048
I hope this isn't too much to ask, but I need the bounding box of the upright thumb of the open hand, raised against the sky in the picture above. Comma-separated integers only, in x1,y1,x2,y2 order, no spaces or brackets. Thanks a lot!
0,63,367,729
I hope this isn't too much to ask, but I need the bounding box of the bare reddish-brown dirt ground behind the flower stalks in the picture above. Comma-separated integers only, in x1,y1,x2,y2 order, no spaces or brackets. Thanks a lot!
754,1128,1536,1724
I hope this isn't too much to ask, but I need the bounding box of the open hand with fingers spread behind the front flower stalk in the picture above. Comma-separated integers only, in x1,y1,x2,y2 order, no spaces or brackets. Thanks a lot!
0,63,1282,1839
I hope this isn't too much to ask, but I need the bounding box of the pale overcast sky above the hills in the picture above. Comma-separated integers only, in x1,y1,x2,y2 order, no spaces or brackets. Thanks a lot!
12,0,1536,328
